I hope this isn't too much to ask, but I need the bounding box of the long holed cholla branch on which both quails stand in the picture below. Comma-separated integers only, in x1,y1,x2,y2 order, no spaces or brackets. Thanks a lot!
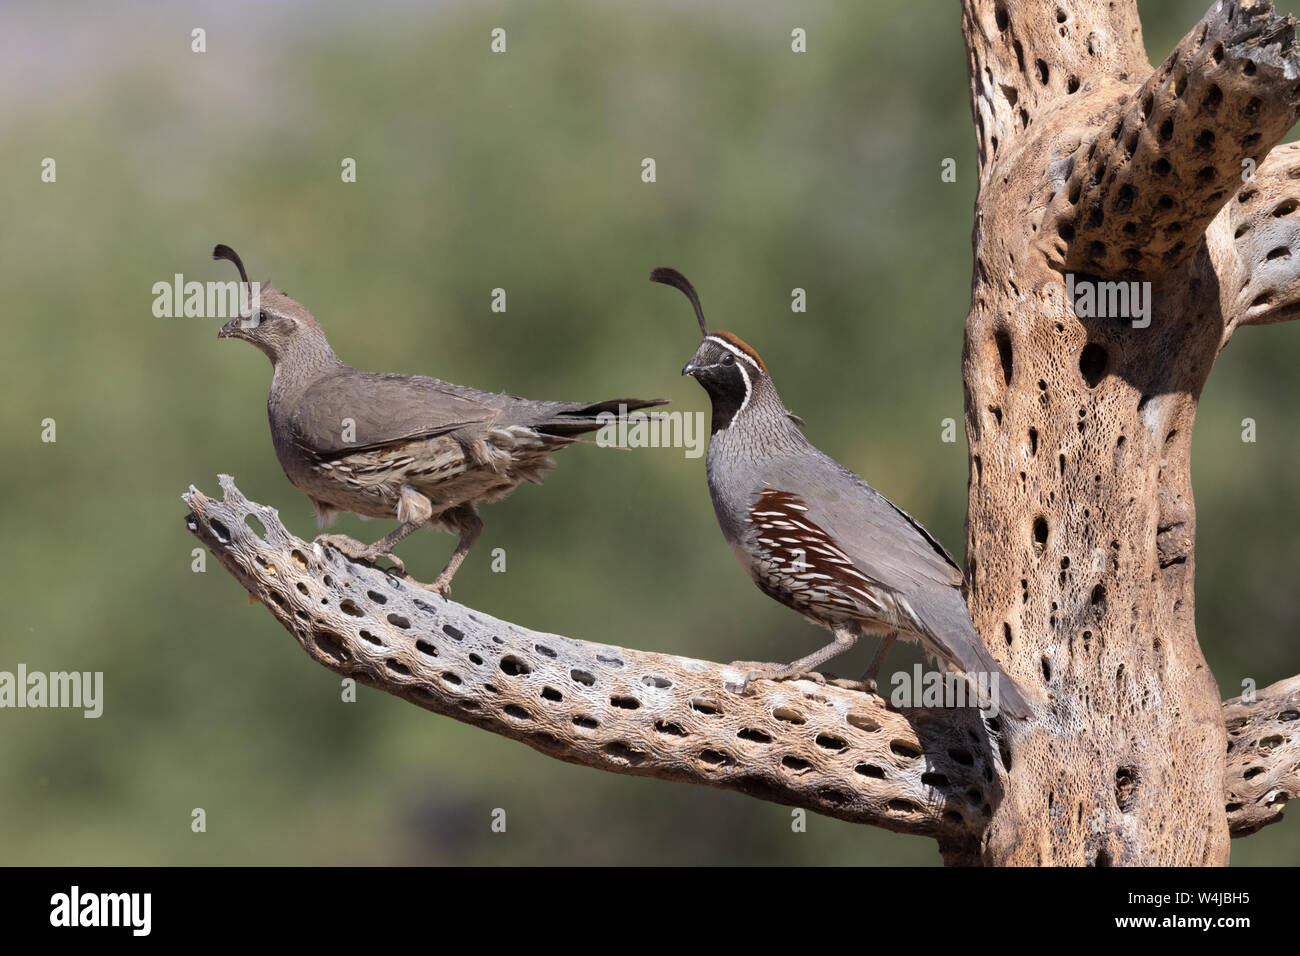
185,475,1001,856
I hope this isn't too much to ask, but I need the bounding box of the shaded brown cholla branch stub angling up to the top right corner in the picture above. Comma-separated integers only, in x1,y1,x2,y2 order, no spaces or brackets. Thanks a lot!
1043,4,1300,276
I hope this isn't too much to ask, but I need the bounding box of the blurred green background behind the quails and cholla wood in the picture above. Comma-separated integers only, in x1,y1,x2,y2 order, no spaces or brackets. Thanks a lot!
0,0,1300,865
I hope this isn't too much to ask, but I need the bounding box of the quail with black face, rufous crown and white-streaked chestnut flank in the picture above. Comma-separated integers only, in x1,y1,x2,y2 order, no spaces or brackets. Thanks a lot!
650,269,1028,717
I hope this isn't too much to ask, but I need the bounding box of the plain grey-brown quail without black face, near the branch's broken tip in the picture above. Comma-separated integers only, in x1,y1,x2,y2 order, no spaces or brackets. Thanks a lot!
212,246,664,594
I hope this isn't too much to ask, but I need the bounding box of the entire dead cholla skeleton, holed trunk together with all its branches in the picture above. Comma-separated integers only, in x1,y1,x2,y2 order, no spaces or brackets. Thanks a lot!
186,0,1300,865
